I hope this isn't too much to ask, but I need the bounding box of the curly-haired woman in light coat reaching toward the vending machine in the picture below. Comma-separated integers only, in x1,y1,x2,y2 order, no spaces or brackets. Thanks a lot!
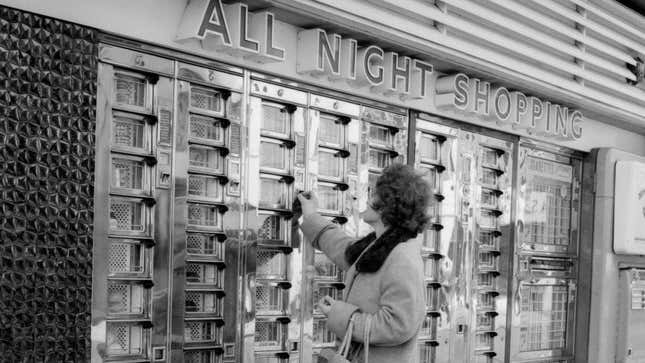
298,164,430,363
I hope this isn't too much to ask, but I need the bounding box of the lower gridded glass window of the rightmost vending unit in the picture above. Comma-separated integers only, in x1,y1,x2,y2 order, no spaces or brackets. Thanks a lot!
520,285,569,352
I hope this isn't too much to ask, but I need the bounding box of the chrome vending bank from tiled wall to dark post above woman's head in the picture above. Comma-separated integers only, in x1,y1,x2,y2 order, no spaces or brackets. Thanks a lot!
92,44,408,363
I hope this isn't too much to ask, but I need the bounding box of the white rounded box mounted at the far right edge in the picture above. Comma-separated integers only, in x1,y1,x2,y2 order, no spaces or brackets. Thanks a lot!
614,161,645,255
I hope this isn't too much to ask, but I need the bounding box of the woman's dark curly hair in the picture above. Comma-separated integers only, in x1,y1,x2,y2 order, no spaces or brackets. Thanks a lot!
373,164,431,238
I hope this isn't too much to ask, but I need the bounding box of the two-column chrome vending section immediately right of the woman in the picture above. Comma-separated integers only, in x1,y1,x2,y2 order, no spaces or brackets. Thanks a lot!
410,113,515,363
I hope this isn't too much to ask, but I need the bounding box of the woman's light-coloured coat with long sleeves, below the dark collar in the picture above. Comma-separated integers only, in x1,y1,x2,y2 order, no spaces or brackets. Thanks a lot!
300,214,425,363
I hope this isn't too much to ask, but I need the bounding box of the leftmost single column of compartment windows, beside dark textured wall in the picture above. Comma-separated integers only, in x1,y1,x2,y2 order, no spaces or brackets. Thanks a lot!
92,61,174,362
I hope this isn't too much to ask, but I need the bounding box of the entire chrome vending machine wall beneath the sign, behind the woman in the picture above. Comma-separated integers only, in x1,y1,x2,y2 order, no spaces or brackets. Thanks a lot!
92,45,581,363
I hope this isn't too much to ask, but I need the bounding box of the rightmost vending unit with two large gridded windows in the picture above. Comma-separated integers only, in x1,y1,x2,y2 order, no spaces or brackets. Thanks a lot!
510,141,582,363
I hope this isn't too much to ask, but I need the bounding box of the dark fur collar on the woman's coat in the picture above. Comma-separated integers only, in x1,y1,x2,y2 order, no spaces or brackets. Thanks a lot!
345,228,414,272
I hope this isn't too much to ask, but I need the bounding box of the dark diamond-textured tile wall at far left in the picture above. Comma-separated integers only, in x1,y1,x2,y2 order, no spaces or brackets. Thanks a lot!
0,6,97,363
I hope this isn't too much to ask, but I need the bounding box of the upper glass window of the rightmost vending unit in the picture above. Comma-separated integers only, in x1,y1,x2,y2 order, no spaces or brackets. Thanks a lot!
524,157,573,245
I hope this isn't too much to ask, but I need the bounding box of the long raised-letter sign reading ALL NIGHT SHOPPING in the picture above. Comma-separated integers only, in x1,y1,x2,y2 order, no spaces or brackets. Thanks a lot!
176,0,583,140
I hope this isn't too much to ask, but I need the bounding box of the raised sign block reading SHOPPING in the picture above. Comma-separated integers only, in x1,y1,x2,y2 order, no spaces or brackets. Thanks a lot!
435,73,582,139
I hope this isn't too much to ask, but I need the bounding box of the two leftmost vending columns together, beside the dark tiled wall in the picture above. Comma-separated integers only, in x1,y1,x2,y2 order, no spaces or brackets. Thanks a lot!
91,45,244,362
